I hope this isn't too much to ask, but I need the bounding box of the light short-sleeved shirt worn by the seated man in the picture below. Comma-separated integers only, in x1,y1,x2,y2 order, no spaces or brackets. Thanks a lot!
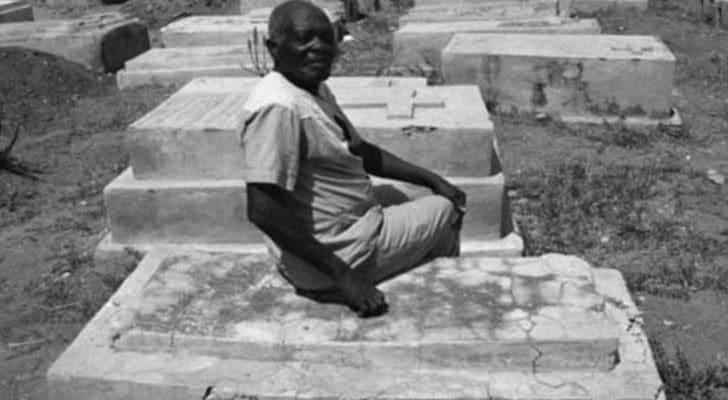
242,72,383,269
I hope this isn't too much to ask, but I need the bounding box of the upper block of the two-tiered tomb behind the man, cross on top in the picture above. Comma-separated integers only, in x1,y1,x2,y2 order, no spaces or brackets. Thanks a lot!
128,78,493,180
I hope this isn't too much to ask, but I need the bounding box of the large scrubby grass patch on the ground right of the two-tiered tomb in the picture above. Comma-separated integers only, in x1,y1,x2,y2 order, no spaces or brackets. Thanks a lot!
509,160,728,298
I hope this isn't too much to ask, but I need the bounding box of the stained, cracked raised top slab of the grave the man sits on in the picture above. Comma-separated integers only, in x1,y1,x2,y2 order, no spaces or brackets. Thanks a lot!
115,253,619,372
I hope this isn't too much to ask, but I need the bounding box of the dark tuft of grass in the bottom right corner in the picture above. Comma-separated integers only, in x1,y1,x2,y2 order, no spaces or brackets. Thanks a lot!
650,340,728,400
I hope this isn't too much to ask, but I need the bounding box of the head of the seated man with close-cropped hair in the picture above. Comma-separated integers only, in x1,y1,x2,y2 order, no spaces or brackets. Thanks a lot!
266,0,337,92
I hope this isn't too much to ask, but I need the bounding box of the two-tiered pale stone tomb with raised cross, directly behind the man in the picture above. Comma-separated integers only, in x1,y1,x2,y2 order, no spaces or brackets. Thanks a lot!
97,78,522,259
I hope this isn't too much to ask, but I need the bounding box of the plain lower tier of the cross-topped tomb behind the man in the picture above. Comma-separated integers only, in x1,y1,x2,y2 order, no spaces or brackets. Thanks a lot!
104,169,510,245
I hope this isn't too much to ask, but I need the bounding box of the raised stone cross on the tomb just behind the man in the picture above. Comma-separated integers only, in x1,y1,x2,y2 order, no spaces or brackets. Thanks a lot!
336,88,445,119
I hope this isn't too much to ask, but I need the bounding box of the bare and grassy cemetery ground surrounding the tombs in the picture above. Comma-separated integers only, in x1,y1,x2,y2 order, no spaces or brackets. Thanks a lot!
0,0,728,400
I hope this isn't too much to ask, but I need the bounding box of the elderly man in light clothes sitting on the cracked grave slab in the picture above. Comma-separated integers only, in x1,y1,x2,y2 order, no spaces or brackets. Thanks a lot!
242,0,465,317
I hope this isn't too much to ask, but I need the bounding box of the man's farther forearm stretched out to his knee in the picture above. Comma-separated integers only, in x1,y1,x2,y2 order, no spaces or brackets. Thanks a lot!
351,140,466,213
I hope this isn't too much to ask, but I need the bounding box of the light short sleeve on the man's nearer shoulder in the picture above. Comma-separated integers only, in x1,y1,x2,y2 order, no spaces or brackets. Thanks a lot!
241,105,302,191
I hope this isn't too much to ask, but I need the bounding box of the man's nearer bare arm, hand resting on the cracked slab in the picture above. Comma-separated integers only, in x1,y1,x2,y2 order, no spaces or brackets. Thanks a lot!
247,183,387,317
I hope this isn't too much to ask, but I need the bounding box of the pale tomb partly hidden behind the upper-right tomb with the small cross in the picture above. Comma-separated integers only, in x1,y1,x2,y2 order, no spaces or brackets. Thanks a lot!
394,16,601,68
